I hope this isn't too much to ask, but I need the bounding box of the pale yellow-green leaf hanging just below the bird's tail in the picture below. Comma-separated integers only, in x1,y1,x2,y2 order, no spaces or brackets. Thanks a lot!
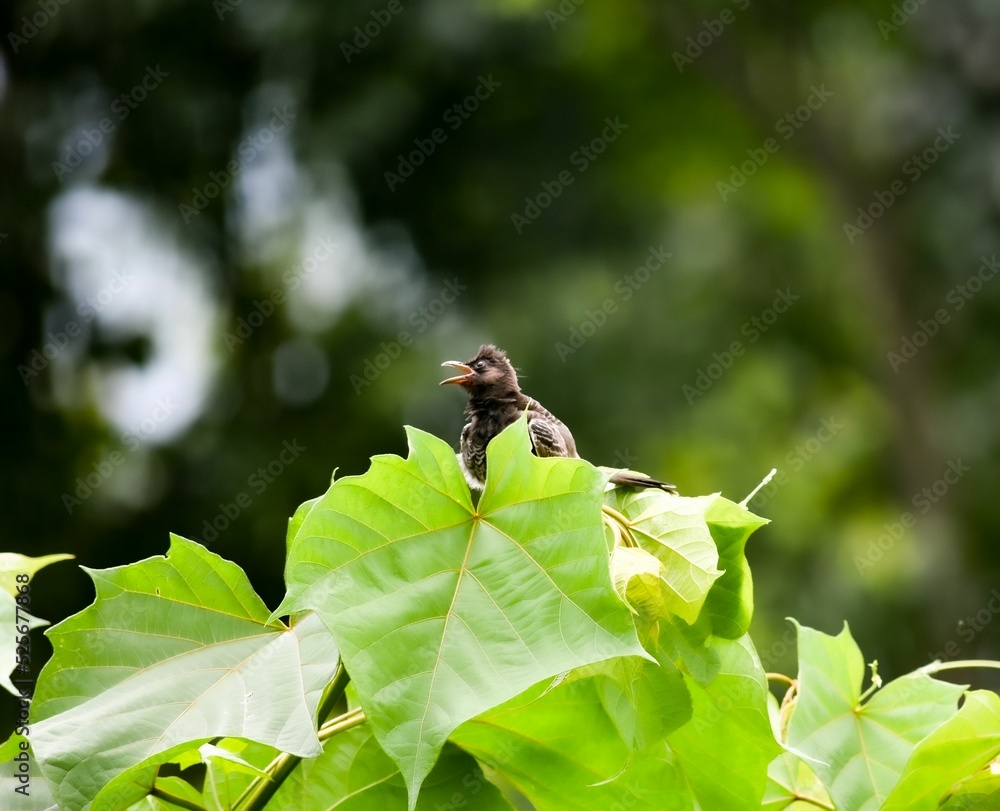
605,487,722,623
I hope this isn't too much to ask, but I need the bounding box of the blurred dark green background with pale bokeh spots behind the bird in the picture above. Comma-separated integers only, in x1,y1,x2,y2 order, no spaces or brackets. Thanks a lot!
0,0,1000,732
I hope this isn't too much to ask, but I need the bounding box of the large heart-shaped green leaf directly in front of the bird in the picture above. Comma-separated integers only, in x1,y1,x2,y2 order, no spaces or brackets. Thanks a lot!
275,419,647,804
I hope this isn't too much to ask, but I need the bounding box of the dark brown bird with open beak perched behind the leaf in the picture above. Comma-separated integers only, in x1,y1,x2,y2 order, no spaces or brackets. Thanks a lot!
440,344,677,493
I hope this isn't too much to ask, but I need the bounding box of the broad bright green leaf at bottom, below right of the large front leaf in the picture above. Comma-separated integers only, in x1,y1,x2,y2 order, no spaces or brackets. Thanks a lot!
452,639,780,811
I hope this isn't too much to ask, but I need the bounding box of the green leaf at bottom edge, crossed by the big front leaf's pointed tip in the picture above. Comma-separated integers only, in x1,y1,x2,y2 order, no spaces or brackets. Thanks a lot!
267,725,511,811
